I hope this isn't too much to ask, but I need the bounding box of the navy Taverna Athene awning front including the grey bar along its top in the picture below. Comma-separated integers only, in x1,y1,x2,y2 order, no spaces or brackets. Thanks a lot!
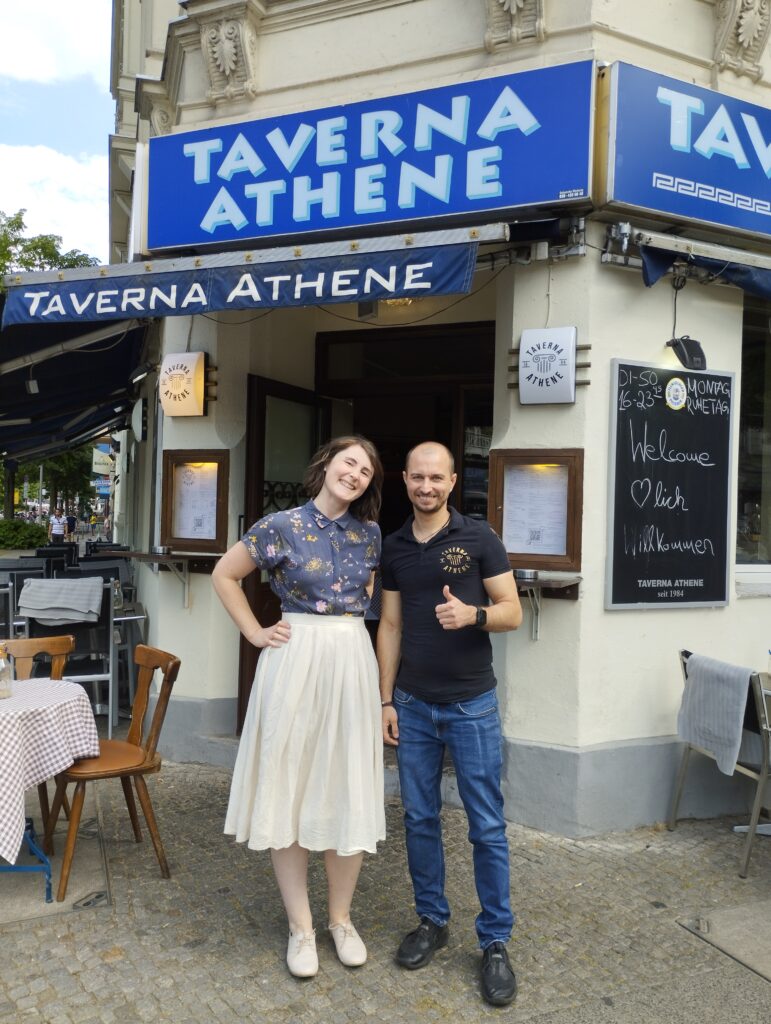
2,224,508,328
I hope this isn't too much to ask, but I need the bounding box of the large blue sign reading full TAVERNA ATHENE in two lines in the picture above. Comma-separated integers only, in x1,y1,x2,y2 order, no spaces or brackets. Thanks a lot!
147,60,594,249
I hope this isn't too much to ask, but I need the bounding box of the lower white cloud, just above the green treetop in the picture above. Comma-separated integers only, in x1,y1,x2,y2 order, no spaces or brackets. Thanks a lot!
0,144,109,262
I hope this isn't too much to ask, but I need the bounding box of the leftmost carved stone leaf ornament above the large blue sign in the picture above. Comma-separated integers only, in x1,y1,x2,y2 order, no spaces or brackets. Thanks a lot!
201,9,257,103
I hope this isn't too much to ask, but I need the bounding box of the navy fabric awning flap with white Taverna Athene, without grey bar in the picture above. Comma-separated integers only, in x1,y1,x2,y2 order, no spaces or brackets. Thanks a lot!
3,242,477,328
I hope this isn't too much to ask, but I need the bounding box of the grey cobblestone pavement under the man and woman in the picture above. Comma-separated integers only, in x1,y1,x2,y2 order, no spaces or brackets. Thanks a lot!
0,764,771,1024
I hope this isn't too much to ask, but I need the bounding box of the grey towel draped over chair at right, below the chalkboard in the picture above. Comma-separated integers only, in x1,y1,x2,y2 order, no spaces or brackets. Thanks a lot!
677,654,753,775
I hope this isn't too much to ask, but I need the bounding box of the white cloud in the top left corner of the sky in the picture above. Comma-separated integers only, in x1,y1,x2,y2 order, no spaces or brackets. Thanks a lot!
0,0,112,91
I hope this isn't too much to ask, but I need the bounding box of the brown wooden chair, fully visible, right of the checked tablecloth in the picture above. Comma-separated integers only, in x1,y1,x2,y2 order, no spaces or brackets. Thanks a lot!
45,644,180,903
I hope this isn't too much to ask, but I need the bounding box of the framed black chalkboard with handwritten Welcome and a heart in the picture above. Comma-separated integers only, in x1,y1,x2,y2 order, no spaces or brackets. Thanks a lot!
605,359,734,608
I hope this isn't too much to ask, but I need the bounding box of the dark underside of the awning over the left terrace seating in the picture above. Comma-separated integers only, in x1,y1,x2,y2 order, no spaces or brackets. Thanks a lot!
0,307,146,460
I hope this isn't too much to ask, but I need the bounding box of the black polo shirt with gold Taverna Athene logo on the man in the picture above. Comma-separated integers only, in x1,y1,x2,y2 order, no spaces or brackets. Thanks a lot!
381,509,511,703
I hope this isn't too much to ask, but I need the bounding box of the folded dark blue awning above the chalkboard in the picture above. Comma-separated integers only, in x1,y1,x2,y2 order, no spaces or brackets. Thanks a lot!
632,231,771,299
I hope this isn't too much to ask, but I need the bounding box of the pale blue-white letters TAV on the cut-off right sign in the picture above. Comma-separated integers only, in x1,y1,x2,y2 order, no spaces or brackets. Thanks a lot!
656,86,771,177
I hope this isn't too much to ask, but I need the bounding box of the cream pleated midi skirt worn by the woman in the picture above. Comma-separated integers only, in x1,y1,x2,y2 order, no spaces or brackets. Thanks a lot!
224,613,385,855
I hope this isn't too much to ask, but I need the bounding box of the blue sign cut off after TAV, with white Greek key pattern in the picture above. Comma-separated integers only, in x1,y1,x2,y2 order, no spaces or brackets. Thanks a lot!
608,63,771,236
